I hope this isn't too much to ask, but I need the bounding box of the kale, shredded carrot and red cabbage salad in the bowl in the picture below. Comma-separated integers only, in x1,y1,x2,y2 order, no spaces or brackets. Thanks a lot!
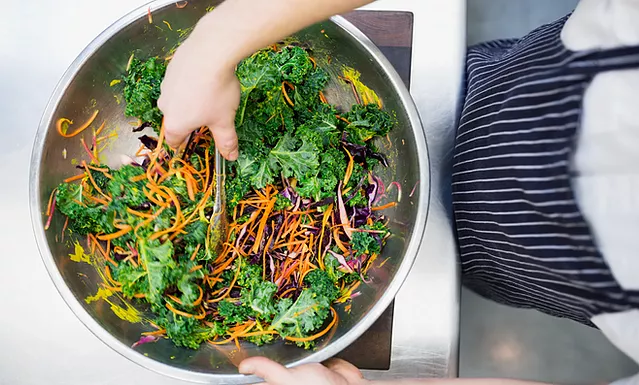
55,44,393,349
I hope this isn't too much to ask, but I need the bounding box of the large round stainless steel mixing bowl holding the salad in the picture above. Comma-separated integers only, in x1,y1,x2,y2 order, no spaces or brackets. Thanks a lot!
30,0,429,384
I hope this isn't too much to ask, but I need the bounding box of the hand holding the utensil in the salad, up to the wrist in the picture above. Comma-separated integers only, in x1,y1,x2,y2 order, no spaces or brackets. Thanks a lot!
158,28,240,160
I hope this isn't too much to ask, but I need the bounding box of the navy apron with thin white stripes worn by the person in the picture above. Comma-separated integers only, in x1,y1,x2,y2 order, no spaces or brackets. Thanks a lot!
453,17,639,325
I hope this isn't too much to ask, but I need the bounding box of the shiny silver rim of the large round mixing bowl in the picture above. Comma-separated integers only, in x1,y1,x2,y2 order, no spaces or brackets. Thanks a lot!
29,0,431,384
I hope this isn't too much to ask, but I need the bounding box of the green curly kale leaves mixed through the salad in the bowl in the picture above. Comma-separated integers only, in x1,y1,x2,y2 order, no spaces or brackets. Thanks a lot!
56,46,393,349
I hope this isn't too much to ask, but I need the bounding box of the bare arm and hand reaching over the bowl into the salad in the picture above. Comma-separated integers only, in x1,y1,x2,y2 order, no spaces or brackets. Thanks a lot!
158,0,372,160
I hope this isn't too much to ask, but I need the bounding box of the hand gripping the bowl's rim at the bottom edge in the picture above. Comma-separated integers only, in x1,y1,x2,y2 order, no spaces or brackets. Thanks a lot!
239,357,368,385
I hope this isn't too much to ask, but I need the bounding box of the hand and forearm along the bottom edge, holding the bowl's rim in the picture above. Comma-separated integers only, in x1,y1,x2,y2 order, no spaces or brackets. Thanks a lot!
239,357,548,385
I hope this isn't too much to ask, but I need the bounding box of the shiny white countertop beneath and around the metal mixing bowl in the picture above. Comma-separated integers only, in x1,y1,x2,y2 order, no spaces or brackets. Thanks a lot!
0,0,466,385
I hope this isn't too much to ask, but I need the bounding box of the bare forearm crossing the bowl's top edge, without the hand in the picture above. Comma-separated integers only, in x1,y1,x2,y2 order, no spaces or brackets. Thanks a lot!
192,0,373,65
